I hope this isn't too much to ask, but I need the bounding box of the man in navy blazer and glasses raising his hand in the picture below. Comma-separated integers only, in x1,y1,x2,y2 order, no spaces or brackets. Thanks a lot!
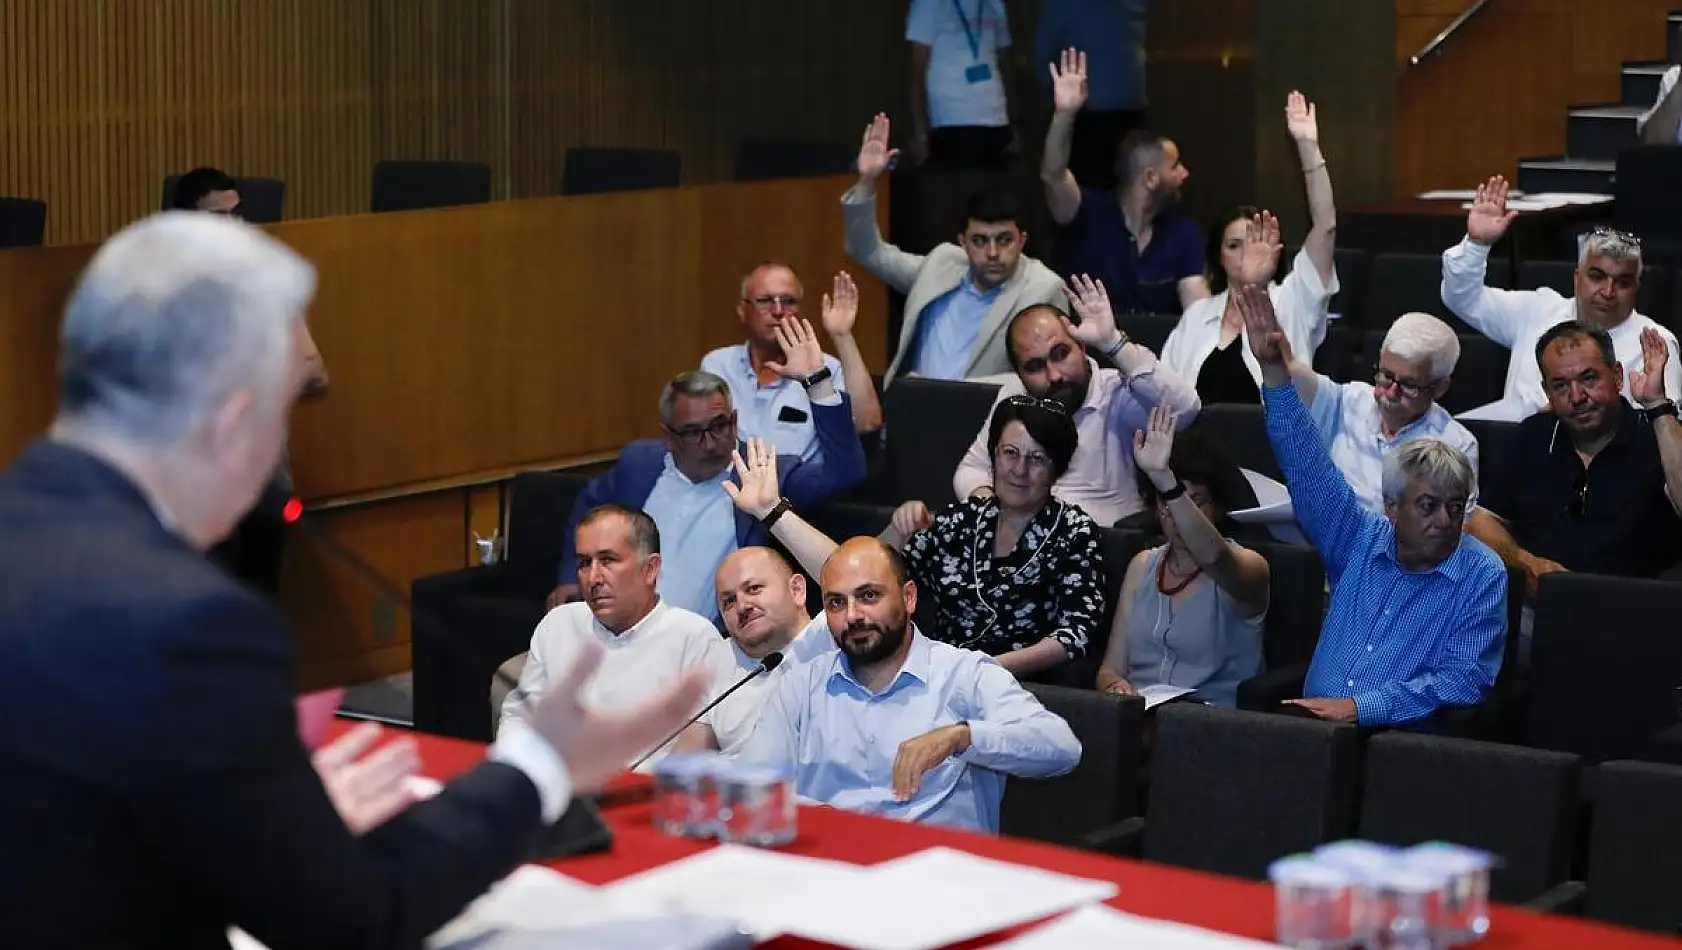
548,359,865,622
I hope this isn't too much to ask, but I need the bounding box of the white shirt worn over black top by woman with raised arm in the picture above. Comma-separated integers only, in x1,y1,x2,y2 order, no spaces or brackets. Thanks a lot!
1162,251,1339,388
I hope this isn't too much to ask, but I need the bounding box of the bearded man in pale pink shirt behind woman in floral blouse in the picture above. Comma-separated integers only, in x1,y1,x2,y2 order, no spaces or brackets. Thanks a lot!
952,276,1203,525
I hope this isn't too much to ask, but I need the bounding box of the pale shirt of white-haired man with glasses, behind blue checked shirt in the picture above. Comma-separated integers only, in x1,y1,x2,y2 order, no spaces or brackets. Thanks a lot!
1309,377,1477,515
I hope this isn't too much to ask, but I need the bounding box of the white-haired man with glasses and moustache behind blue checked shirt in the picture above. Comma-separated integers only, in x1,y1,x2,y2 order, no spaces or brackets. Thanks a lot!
1287,313,1477,515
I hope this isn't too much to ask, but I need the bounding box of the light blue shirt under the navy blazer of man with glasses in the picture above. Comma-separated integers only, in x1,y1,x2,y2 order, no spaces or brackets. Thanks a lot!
643,452,737,624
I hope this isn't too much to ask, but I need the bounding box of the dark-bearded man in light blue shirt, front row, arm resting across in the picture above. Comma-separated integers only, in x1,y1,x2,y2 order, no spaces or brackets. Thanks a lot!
740,538,1080,834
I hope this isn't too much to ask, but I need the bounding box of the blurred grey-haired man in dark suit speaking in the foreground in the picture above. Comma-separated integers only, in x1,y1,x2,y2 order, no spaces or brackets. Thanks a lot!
0,212,706,950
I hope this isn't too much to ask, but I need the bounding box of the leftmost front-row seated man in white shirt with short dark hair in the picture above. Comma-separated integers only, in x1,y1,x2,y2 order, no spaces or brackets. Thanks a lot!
493,504,730,770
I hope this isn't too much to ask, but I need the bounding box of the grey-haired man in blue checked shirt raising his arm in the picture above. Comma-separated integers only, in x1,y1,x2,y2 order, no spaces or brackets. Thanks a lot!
1238,284,1507,726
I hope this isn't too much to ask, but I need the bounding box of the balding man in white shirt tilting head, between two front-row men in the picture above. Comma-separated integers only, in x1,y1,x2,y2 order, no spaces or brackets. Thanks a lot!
676,548,836,755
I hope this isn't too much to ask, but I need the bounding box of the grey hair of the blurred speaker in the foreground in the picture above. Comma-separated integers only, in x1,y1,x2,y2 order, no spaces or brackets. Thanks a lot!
59,212,316,446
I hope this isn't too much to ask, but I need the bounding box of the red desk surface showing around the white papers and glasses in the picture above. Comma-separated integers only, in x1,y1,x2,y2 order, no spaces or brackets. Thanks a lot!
390,735,1682,950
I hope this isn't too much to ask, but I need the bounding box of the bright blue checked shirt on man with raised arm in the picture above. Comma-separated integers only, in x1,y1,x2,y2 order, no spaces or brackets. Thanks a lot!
1262,385,1507,726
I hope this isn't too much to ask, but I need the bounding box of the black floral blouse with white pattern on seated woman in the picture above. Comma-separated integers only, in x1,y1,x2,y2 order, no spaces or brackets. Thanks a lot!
905,498,1103,659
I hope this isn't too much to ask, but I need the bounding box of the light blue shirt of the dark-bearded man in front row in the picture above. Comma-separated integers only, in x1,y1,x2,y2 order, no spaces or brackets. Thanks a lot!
740,629,1080,832
